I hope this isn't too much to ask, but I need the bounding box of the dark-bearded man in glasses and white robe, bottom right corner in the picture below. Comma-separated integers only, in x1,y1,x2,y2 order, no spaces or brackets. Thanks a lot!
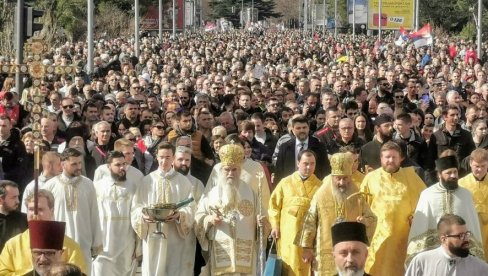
405,214,488,276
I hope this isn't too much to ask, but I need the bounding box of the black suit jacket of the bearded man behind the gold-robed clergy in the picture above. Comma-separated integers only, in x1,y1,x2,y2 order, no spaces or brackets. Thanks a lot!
275,136,330,184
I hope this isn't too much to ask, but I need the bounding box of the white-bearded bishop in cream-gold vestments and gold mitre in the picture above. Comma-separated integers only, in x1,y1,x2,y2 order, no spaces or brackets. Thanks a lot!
195,144,270,276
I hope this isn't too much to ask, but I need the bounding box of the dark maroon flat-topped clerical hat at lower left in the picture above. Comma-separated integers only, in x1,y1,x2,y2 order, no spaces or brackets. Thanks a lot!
29,220,66,250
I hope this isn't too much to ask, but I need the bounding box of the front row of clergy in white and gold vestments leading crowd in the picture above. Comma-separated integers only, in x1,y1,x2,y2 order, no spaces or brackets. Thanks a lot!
0,135,488,276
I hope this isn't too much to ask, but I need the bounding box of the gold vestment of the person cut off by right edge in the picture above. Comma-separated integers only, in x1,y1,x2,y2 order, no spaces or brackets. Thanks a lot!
459,173,488,261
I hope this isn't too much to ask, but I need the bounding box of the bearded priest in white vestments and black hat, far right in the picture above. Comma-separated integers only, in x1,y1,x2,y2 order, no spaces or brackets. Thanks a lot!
406,154,482,264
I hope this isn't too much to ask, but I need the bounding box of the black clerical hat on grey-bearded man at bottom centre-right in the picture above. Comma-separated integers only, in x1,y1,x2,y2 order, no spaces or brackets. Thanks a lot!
331,221,369,246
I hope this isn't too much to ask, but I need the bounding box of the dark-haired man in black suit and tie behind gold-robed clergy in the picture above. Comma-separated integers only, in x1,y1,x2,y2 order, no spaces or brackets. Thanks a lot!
274,116,330,183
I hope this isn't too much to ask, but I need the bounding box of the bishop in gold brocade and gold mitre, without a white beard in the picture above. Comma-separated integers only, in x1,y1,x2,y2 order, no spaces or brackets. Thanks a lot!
296,153,376,275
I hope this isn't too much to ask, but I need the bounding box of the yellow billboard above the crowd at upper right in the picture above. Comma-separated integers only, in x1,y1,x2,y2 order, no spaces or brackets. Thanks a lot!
368,0,415,30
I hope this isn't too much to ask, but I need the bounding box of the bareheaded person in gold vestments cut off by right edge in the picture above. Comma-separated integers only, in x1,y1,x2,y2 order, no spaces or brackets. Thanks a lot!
459,148,488,261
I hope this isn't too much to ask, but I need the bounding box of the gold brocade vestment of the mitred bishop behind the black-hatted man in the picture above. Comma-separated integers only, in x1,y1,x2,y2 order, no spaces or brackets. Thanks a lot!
297,179,376,275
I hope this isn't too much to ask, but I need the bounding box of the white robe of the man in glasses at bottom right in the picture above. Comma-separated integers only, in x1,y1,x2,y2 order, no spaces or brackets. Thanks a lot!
405,246,488,276
